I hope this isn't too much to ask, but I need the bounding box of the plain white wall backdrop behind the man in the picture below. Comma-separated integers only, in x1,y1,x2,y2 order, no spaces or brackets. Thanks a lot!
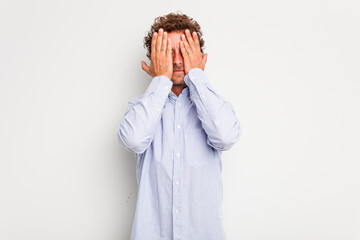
0,0,360,240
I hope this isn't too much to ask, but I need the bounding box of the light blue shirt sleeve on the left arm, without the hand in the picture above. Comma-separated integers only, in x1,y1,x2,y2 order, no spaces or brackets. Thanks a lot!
117,75,173,154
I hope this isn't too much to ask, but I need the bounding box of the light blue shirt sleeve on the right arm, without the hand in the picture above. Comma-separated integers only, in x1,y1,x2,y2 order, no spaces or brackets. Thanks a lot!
184,68,241,151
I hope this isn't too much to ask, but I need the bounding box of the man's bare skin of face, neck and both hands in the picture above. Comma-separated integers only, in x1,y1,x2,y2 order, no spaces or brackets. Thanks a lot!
141,28,208,96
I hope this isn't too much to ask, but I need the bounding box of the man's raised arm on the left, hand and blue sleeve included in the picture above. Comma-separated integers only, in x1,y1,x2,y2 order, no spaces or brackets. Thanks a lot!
118,28,173,154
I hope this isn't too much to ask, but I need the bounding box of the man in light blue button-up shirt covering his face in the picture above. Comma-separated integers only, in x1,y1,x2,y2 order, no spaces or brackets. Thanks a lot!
118,13,240,240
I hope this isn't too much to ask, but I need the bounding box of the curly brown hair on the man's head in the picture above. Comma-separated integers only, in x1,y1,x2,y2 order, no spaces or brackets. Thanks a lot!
144,11,205,60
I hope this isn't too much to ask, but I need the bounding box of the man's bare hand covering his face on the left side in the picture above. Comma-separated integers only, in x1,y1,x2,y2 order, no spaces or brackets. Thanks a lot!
141,28,173,79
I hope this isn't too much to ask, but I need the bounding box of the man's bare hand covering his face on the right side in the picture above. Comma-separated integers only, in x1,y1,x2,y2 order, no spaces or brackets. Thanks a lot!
180,29,208,74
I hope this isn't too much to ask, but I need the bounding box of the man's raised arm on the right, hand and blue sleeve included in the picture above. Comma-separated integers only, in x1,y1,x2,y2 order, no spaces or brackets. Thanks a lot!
180,29,240,151
